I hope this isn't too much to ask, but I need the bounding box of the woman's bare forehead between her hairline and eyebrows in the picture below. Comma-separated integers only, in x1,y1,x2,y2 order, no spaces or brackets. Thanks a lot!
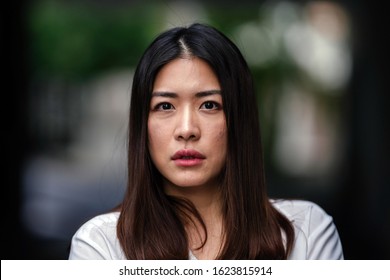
153,58,220,93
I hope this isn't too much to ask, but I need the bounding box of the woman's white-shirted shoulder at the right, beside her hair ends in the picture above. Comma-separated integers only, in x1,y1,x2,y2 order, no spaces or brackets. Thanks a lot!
271,200,343,259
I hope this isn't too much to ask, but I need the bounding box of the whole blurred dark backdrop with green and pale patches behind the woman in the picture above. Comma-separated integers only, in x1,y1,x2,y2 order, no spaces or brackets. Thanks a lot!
1,0,390,259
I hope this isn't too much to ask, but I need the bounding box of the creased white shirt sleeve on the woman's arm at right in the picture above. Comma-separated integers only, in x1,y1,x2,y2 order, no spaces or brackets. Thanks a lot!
307,201,344,260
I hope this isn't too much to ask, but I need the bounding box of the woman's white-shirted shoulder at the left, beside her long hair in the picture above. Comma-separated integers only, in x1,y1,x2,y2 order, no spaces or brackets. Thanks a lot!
69,212,123,259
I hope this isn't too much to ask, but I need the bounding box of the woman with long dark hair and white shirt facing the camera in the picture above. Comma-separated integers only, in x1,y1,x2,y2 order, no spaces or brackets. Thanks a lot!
69,24,343,259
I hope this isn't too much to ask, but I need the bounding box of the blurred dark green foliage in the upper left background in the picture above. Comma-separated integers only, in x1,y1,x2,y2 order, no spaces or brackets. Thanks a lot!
29,1,165,80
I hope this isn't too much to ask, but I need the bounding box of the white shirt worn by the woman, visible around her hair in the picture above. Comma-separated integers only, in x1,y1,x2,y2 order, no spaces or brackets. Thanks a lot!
69,200,344,260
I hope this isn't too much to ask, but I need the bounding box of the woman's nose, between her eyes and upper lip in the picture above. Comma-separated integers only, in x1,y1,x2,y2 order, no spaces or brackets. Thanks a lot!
175,108,200,141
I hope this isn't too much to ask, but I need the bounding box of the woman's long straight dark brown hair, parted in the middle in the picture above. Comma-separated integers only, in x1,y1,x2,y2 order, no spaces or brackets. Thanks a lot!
117,24,294,259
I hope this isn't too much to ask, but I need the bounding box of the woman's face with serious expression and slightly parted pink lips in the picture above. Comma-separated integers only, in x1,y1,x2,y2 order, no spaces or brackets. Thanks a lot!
148,58,227,191
